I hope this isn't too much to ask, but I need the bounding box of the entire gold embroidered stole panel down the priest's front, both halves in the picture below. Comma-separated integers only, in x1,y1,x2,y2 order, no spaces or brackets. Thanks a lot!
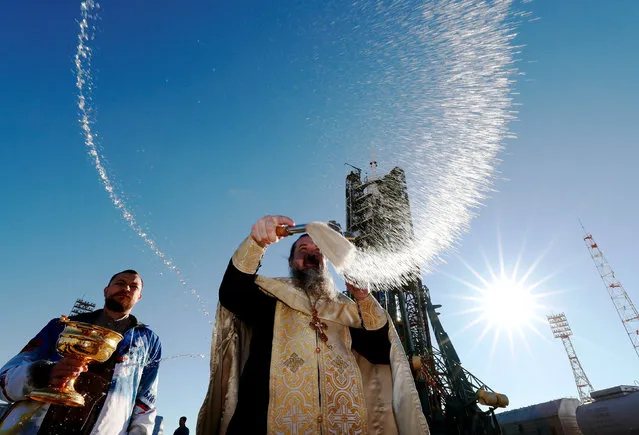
268,302,367,435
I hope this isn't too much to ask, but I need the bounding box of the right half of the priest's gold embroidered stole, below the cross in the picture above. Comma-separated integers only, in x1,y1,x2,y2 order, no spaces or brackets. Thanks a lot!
320,323,367,435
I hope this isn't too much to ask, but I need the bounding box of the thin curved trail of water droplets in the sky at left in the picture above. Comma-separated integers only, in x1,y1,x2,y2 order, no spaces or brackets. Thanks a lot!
74,0,212,323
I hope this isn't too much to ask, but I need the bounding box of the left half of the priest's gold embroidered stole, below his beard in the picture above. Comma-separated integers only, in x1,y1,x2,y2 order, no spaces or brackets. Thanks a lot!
268,302,320,435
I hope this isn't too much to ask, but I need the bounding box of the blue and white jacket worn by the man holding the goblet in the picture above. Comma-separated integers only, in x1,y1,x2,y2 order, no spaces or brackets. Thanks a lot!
0,310,162,435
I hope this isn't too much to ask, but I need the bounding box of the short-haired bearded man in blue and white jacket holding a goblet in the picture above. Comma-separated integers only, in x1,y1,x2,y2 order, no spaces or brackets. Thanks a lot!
0,269,162,435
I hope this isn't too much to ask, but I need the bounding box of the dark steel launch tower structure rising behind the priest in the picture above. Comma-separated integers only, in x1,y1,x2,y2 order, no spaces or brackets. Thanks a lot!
346,164,508,435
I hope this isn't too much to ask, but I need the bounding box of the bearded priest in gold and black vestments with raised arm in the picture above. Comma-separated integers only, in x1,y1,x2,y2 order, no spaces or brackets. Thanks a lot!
197,216,429,435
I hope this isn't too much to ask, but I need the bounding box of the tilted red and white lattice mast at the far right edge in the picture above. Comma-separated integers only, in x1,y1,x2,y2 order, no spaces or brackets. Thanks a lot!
579,221,639,356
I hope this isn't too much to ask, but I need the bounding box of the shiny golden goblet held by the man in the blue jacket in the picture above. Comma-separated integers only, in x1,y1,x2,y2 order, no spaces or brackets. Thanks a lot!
28,316,123,406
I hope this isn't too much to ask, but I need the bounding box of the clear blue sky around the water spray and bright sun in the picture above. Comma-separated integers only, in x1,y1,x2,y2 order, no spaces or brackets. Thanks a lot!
0,0,639,428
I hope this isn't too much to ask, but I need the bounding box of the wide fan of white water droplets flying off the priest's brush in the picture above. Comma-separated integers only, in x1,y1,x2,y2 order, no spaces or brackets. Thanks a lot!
340,0,518,286
